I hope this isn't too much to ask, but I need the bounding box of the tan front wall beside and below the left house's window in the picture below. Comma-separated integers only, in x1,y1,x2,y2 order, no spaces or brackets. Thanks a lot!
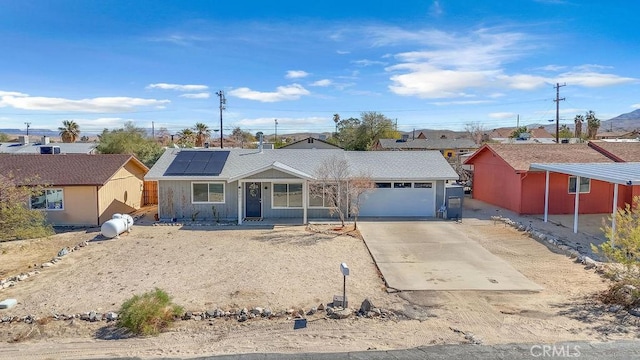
46,186,99,226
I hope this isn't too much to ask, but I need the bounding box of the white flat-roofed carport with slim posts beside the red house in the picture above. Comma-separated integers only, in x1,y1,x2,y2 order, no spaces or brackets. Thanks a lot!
530,162,640,233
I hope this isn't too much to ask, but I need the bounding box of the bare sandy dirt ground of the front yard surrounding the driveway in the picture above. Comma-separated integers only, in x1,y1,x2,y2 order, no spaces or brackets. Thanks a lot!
0,204,639,359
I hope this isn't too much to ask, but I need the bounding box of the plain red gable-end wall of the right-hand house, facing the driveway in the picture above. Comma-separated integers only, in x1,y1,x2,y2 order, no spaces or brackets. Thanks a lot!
472,151,524,213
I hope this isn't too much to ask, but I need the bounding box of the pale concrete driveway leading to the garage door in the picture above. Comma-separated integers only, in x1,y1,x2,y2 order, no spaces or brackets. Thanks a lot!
358,221,542,291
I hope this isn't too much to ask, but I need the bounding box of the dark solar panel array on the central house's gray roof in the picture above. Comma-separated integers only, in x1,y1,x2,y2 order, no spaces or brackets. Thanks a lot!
164,150,229,176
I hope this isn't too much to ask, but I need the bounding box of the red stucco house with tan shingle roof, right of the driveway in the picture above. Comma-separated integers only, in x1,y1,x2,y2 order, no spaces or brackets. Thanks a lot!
465,144,640,214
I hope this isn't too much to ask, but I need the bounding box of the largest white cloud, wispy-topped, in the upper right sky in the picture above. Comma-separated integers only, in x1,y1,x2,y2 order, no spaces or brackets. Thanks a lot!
380,29,638,98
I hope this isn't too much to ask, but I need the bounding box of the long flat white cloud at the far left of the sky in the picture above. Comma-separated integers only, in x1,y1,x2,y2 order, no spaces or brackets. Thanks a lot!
0,92,170,113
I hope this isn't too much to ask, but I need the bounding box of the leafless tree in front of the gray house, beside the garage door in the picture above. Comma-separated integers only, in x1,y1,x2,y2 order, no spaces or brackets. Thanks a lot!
309,155,373,228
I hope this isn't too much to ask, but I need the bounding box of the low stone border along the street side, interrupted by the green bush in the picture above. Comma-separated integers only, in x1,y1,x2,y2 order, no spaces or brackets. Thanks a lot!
0,299,404,324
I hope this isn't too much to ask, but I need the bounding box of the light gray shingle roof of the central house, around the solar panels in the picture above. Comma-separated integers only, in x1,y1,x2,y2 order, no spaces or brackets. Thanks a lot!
145,149,458,180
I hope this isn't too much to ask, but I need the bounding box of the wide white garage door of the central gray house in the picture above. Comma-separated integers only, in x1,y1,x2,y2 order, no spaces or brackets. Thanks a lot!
360,183,436,217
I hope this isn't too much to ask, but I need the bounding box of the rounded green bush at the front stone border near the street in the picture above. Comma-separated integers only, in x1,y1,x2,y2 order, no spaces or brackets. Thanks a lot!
118,288,183,335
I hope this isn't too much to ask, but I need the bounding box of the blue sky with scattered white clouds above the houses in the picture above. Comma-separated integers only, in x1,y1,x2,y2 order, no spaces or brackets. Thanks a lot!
0,0,640,134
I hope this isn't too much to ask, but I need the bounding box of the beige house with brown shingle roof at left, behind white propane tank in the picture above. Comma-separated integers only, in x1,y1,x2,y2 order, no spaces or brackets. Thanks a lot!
0,154,149,226
